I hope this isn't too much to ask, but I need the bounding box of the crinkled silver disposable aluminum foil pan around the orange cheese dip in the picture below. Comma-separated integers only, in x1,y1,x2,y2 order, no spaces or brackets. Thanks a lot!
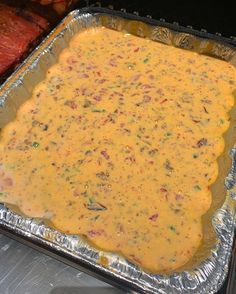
0,8,236,294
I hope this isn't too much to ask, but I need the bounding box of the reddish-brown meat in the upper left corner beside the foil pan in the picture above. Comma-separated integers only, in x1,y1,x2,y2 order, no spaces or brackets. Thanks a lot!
0,0,79,84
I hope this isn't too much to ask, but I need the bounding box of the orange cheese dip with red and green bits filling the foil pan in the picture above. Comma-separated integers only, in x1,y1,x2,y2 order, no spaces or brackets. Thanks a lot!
0,28,236,272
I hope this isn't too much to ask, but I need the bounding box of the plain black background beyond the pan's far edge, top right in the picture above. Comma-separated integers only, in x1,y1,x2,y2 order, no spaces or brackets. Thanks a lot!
84,0,236,37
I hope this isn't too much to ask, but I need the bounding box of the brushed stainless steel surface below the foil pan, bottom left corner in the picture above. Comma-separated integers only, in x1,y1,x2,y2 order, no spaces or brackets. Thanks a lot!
0,234,125,294
